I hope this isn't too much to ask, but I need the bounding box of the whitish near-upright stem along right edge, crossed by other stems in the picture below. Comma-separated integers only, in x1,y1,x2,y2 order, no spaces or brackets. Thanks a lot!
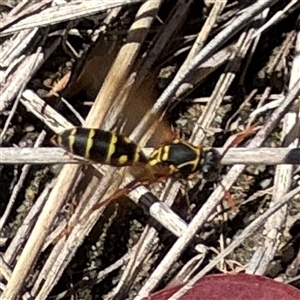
246,25,300,275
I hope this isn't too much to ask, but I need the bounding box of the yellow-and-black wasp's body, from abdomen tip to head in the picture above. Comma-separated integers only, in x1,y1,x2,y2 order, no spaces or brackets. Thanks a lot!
51,127,220,180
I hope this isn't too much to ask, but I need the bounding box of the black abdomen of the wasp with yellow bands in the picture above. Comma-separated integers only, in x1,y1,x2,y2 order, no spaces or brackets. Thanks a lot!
51,127,147,167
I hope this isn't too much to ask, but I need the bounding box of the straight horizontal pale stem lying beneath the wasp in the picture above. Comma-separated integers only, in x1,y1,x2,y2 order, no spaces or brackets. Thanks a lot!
0,147,300,165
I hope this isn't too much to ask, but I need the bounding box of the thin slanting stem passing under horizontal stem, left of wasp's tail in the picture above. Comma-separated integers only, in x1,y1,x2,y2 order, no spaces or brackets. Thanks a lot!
0,131,46,232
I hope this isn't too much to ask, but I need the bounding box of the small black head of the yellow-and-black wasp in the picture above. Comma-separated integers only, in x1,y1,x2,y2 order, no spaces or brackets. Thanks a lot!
201,149,221,181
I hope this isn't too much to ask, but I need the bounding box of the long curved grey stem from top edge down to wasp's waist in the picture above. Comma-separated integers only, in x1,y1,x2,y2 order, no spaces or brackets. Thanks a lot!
133,0,278,140
